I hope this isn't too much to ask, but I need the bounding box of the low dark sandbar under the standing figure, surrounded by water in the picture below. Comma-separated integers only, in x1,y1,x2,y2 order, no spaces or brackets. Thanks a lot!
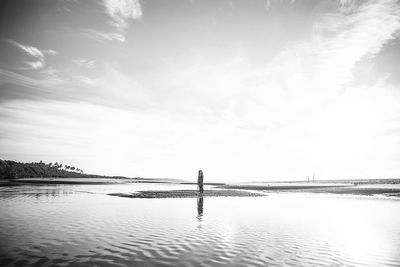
109,189,265,198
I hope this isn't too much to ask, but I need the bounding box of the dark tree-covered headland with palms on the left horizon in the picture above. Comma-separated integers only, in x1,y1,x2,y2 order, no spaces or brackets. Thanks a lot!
0,159,111,179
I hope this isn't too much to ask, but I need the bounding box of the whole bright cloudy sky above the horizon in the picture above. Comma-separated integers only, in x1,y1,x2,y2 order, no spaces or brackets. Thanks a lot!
0,0,400,182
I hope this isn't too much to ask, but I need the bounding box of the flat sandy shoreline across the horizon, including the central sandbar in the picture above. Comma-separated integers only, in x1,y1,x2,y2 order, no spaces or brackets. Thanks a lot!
0,177,400,198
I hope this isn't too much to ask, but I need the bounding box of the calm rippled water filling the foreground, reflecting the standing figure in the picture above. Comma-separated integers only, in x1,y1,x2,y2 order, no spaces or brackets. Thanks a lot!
0,184,400,266
